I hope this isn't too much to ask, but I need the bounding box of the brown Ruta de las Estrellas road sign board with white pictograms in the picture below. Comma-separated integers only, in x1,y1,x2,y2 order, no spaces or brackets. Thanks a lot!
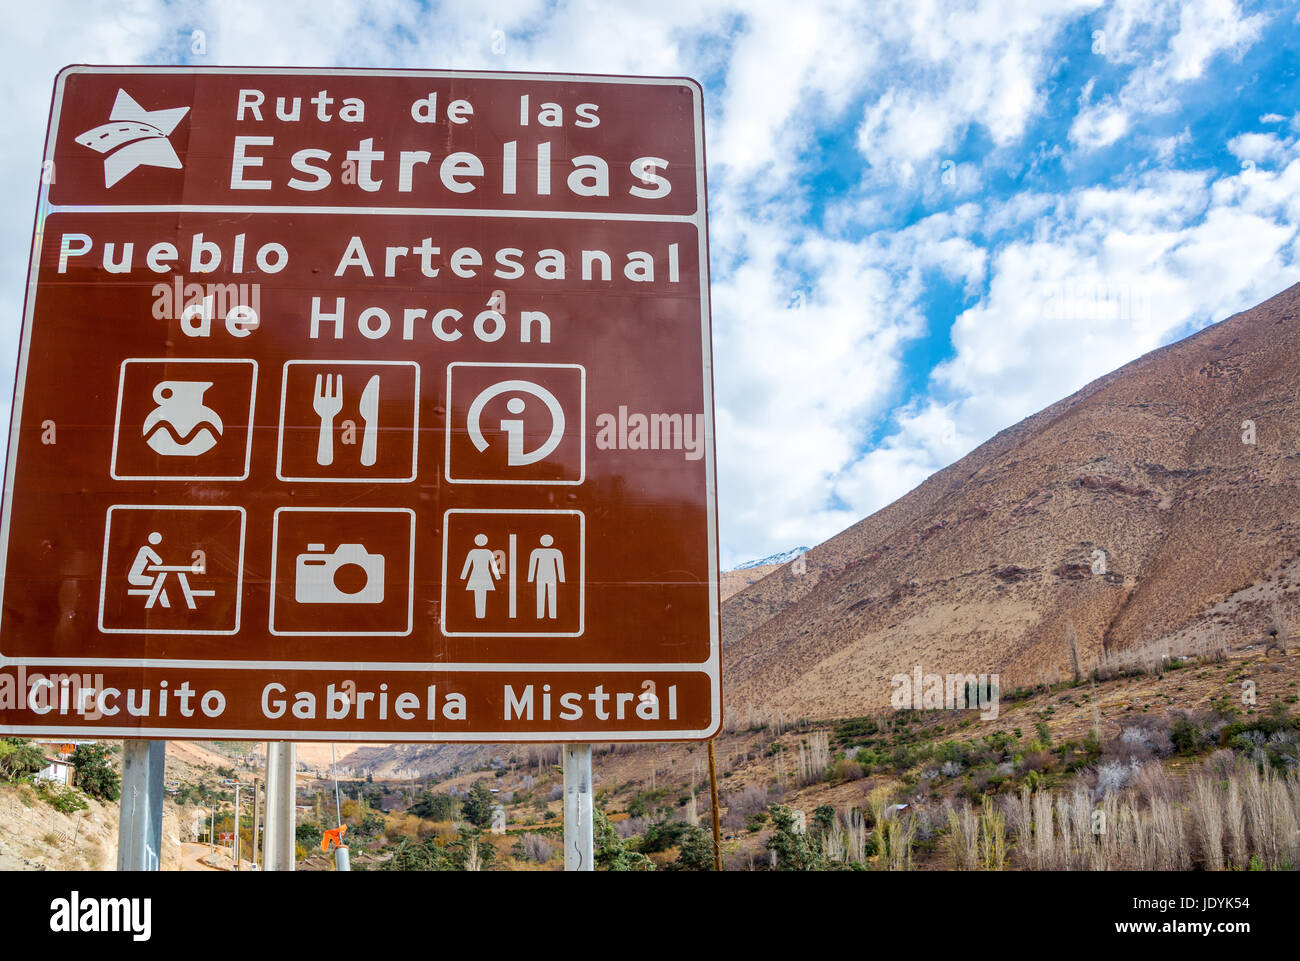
0,66,722,741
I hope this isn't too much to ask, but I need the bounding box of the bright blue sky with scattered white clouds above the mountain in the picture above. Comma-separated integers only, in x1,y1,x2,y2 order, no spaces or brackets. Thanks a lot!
0,0,1300,566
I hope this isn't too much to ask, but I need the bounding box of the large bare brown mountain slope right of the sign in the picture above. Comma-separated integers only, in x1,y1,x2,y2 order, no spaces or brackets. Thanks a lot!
723,285,1300,722
